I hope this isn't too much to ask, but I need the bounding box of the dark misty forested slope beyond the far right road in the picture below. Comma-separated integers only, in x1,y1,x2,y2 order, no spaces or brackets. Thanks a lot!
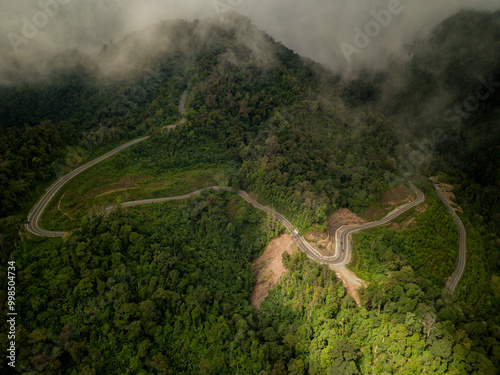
348,11,500,274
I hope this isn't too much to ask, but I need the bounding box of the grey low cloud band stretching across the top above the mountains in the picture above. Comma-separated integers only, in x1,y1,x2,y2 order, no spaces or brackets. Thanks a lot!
0,0,500,83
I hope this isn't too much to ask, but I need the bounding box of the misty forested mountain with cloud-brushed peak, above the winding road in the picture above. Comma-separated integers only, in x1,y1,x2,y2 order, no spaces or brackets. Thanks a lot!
0,17,395,232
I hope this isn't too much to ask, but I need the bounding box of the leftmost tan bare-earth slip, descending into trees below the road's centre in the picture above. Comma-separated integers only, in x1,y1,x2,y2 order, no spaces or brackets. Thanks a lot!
250,234,297,309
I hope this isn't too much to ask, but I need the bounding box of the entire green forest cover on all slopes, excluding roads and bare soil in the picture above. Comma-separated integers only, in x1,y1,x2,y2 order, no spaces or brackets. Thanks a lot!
0,12,500,375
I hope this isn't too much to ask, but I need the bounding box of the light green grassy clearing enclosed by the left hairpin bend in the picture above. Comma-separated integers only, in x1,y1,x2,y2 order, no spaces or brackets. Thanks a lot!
41,144,225,230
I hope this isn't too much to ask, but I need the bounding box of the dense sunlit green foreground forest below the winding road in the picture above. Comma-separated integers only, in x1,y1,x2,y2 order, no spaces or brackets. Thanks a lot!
1,193,500,374
